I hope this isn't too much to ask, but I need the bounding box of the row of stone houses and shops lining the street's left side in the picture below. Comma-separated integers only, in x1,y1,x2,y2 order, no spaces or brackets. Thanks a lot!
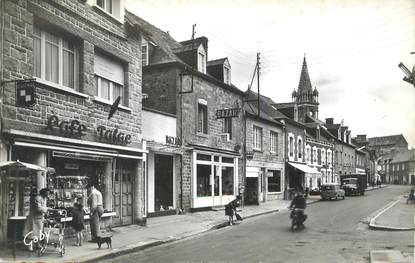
0,0,413,248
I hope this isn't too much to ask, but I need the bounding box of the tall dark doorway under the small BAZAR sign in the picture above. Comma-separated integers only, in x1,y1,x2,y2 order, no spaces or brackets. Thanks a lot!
154,154,174,212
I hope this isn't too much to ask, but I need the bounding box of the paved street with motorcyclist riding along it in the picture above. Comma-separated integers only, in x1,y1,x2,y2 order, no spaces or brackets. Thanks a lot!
102,186,414,263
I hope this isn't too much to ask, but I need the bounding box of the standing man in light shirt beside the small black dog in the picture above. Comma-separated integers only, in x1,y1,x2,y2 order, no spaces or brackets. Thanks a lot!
87,184,104,242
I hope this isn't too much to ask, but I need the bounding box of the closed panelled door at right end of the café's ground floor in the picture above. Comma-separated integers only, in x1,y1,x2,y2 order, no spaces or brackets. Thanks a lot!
113,161,134,226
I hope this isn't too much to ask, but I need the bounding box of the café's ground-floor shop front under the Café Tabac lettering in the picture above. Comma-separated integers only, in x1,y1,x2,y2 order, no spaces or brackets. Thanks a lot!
2,130,146,248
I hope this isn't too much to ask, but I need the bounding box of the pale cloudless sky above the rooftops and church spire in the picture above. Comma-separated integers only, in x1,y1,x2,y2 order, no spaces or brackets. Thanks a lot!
126,0,415,147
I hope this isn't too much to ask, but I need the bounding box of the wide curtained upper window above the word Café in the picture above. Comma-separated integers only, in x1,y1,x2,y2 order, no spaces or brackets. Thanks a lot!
33,26,79,90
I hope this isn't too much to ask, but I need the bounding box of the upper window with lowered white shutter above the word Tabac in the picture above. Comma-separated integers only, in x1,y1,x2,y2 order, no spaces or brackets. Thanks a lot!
94,53,126,105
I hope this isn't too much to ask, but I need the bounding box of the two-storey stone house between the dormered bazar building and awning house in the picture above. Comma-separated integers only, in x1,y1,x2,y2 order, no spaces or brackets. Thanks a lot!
244,91,286,204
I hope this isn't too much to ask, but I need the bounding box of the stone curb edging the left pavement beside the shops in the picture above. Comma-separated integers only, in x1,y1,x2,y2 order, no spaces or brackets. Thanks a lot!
77,200,320,263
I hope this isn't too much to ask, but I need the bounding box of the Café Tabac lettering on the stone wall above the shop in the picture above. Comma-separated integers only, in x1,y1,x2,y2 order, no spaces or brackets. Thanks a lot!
47,115,132,144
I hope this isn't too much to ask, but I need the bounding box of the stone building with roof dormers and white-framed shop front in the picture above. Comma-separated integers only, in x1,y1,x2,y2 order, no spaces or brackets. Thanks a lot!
130,13,245,214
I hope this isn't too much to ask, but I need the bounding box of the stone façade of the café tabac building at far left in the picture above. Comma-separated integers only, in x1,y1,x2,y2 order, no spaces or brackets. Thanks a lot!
0,0,147,246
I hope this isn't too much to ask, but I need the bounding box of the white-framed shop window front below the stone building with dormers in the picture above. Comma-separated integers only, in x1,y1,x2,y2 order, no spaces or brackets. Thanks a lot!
192,151,239,209
